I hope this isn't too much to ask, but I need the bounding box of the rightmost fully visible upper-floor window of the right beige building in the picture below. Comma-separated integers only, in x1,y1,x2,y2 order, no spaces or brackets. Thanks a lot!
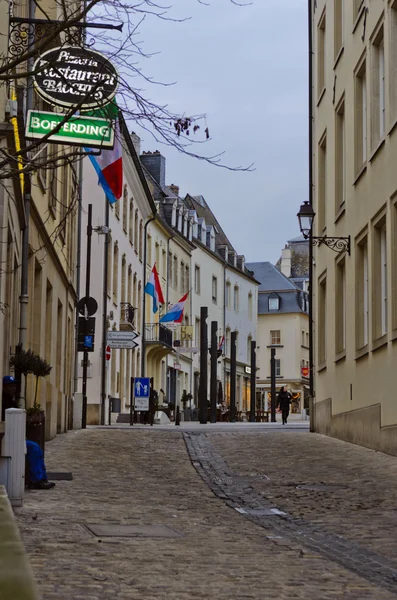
371,27,385,148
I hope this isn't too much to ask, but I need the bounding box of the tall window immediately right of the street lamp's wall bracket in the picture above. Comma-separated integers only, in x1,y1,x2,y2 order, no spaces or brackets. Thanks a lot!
356,236,369,350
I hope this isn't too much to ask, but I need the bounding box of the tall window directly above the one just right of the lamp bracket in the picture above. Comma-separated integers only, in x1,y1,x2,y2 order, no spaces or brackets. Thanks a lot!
355,59,367,172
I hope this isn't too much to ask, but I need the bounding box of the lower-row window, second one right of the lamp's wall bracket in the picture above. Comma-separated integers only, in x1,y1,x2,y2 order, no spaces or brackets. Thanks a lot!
373,217,388,340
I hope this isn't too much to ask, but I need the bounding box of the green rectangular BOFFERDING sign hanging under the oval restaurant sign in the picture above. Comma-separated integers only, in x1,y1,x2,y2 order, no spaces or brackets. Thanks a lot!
25,110,114,149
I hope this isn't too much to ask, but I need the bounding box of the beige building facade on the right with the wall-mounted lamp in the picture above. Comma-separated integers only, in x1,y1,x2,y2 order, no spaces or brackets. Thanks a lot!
311,0,397,454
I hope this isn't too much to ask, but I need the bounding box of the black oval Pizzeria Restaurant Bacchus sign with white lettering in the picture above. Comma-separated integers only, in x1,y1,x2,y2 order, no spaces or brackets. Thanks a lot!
33,46,119,110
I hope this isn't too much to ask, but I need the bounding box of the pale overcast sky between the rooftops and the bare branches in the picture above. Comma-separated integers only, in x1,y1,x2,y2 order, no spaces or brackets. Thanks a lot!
130,0,307,262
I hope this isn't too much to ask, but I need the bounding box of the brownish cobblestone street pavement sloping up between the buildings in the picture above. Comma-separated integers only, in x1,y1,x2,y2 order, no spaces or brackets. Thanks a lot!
13,429,397,600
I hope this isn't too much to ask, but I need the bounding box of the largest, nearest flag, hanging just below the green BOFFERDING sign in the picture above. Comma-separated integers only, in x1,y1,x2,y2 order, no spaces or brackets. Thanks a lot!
86,119,123,204
